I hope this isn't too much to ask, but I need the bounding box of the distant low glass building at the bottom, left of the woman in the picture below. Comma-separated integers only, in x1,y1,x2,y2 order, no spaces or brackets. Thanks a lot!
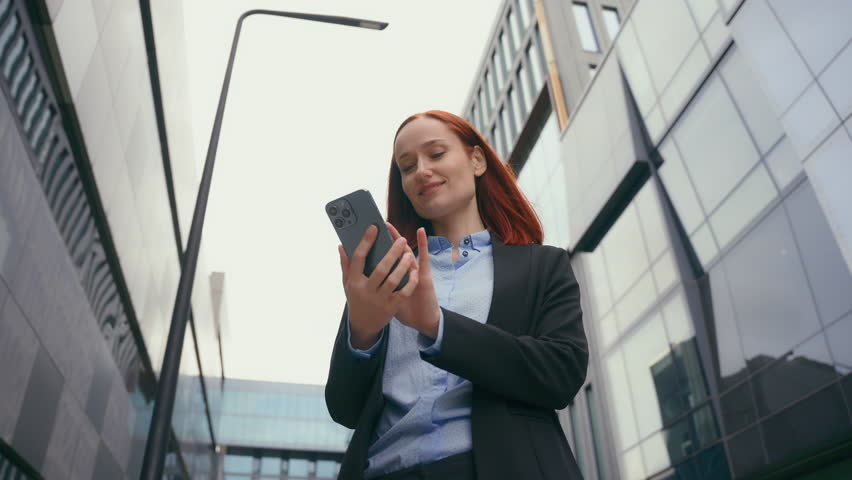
217,379,352,480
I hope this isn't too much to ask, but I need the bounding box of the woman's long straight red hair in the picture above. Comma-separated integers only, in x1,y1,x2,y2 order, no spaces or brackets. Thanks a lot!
388,110,544,248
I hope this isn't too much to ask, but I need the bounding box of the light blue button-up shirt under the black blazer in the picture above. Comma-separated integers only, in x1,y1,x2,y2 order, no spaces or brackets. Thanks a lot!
349,230,494,478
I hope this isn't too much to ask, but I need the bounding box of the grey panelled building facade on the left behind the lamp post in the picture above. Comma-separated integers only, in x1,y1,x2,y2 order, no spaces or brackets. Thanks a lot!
0,0,223,479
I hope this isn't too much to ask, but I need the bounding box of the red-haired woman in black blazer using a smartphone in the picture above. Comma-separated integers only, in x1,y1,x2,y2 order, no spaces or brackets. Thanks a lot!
325,111,588,480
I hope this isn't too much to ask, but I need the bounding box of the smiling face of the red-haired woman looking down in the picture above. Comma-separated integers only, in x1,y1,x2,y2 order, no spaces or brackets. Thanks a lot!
393,117,486,222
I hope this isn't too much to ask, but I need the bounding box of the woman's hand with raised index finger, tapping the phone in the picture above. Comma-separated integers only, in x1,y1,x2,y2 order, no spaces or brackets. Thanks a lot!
388,223,441,339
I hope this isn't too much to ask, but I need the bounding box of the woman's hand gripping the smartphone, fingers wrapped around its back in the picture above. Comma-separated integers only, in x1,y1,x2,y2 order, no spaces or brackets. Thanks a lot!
337,225,420,350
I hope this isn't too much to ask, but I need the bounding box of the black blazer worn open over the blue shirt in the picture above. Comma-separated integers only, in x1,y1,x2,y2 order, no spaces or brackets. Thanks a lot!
325,233,589,480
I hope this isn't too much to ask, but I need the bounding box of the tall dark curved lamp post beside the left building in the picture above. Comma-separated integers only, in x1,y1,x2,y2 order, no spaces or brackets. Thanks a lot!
140,10,388,480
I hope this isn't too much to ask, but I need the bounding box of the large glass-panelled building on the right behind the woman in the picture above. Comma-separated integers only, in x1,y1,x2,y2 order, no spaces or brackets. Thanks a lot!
463,0,852,479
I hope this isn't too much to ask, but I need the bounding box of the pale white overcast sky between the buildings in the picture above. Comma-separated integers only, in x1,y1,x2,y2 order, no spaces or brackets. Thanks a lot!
184,0,502,384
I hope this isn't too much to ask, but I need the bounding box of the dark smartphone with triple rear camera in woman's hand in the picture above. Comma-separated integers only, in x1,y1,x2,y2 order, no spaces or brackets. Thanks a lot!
325,190,408,291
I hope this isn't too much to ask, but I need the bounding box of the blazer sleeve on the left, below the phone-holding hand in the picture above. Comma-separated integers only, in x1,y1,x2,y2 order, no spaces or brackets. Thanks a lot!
325,308,387,428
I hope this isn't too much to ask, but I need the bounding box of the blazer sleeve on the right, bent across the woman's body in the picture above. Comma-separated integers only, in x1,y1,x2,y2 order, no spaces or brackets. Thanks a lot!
421,250,589,409
